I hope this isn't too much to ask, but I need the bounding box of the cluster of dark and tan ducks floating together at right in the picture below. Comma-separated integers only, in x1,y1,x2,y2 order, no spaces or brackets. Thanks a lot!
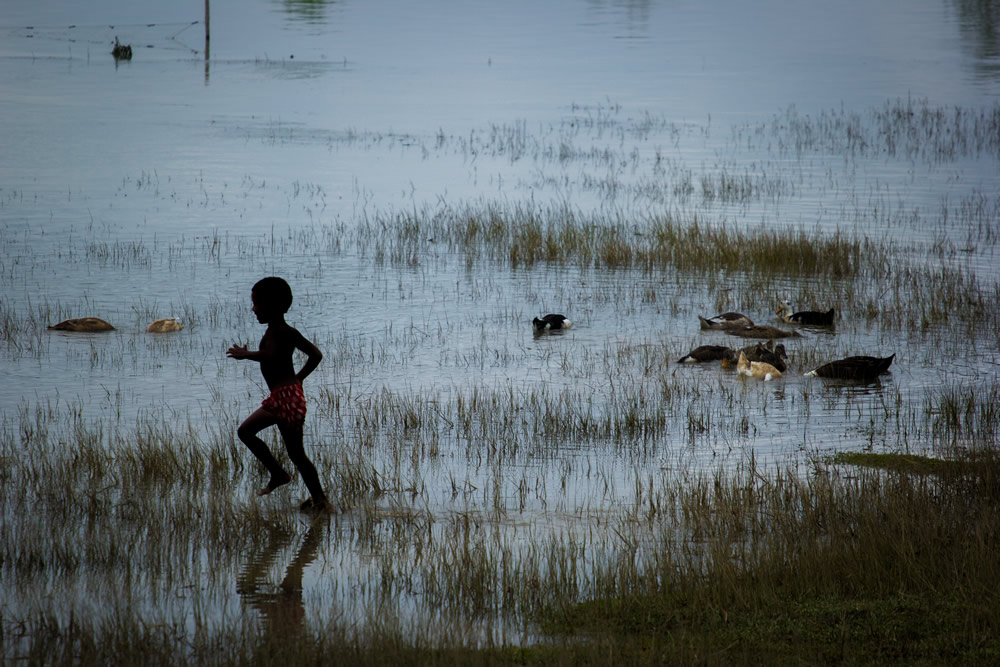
677,299,896,382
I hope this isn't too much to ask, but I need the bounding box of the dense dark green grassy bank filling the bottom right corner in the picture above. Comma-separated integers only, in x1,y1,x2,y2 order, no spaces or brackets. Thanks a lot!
546,453,1000,663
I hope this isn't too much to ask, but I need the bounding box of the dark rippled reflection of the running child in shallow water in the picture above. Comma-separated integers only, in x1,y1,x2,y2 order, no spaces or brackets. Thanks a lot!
236,517,327,633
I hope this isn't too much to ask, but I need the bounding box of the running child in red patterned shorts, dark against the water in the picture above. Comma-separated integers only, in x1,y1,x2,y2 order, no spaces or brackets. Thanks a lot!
226,276,328,511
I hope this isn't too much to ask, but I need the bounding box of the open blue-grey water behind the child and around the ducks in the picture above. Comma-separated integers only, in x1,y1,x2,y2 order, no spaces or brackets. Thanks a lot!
0,0,1000,648
